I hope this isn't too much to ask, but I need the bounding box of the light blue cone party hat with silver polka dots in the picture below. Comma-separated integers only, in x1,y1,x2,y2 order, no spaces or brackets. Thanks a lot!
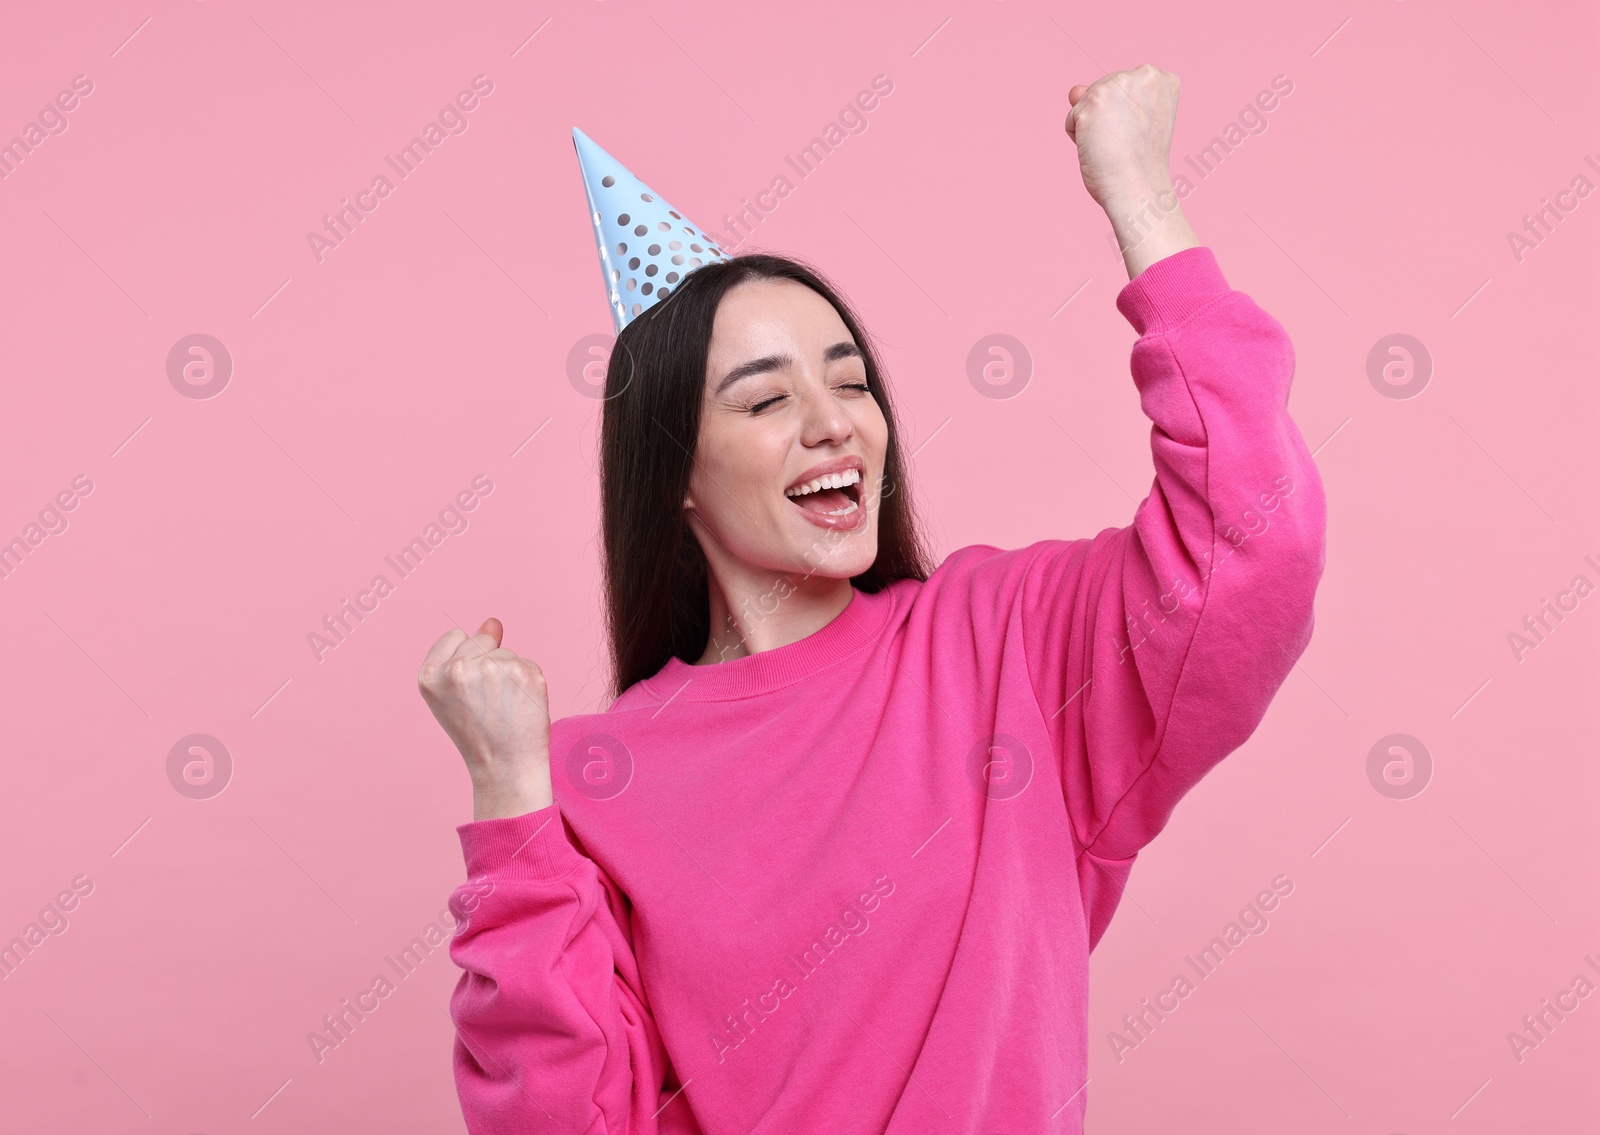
573,126,728,333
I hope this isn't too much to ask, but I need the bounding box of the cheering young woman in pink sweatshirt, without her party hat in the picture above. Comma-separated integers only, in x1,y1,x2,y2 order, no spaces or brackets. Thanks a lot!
419,66,1325,1135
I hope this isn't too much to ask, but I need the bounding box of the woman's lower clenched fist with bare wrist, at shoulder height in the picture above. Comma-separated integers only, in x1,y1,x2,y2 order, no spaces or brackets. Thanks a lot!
416,618,555,820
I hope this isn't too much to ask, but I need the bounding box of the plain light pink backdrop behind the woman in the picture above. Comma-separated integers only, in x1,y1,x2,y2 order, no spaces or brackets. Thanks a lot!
0,0,1600,1135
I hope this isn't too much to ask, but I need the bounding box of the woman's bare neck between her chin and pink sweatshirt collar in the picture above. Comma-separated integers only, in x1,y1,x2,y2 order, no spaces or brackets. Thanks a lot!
696,563,851,666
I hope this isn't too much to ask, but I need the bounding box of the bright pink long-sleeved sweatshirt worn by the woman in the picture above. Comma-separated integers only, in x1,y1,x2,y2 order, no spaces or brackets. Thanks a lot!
450,247,1325,1135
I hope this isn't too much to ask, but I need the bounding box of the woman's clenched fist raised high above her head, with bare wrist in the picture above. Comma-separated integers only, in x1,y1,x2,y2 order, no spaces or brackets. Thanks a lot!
1066,64,1200,280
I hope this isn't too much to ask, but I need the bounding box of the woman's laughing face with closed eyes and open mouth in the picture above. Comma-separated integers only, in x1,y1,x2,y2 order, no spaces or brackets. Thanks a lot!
683,280,888,580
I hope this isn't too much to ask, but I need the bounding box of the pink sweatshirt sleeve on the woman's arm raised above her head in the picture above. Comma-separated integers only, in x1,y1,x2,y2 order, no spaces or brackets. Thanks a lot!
1021,247,1326,948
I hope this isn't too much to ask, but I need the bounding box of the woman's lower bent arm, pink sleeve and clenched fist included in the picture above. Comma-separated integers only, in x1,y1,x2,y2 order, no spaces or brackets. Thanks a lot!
418,618,699,1135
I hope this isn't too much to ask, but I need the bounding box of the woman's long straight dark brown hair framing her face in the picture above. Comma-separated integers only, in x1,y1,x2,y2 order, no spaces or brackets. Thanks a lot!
600,253,930,695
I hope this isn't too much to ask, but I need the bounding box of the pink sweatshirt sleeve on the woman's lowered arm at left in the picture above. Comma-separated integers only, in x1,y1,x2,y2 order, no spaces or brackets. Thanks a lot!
450,804,699,1135
